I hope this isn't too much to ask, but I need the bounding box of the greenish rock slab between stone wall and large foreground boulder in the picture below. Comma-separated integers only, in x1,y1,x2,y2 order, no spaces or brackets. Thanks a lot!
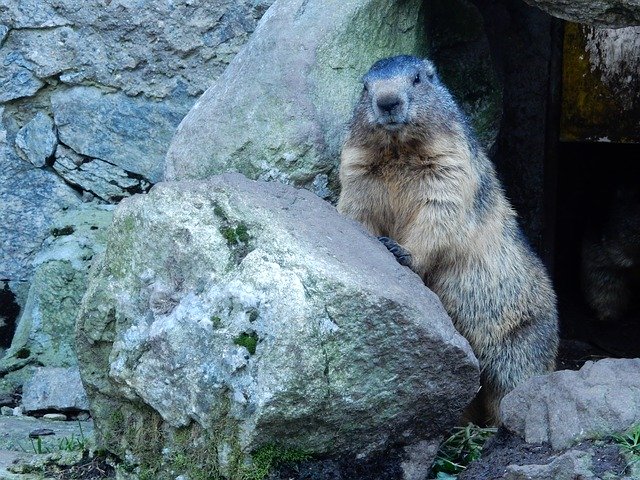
0,205,113,391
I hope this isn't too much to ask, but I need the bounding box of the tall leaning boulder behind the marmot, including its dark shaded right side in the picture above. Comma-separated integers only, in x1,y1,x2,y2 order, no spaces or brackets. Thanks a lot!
165,0,502,199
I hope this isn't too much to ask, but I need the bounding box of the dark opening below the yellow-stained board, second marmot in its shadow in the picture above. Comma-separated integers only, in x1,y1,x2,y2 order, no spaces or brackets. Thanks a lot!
553,143,640,357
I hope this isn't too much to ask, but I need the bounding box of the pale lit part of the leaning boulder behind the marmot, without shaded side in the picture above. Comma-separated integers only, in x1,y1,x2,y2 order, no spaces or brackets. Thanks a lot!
165,0,425,195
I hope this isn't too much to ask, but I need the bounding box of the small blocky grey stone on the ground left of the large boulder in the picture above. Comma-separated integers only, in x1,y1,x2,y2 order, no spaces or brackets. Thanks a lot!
22,367,89,412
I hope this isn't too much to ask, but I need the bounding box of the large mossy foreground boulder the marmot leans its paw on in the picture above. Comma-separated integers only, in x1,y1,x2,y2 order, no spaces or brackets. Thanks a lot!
77,174,478,478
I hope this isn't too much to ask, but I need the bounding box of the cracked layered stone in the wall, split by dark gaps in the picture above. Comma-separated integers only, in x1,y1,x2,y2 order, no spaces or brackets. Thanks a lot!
53,146,151,203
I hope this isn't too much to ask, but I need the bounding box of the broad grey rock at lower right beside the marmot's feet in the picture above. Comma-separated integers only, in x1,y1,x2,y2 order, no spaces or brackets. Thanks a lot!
500,359,640,449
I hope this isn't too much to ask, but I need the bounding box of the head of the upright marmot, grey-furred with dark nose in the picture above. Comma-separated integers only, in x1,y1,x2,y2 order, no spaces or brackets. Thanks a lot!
354,55,464,141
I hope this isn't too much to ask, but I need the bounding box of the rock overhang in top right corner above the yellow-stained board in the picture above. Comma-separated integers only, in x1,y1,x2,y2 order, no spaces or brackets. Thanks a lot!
525,0,640,28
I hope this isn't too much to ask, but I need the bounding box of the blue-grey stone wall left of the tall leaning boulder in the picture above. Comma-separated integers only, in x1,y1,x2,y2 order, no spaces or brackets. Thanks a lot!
0,0,271,288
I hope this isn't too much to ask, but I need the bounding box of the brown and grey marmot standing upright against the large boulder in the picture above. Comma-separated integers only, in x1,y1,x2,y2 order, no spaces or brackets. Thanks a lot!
338,55,558,424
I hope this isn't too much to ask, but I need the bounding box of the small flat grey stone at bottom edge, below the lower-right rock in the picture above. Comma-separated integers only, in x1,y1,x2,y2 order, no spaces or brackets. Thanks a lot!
503,450,596,480
